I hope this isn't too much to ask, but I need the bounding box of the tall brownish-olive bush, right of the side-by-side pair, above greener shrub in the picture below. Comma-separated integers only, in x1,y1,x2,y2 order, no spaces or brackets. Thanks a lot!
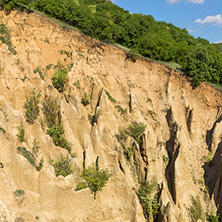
42,97,60,128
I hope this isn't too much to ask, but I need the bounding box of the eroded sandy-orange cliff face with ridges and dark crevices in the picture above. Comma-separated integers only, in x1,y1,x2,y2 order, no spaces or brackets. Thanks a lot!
0,12,222,222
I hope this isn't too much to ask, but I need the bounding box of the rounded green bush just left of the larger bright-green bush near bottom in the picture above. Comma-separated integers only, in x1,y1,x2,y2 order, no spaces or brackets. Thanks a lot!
53,154,73,177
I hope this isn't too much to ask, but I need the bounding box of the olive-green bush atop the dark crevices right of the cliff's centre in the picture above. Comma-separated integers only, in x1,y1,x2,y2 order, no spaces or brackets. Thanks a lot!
127,121,146,144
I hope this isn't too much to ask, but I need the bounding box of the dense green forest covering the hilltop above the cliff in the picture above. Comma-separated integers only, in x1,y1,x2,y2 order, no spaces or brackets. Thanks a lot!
0,0,222,87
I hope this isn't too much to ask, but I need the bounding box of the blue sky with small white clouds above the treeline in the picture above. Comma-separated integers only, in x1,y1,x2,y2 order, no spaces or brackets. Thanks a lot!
113,0,222,43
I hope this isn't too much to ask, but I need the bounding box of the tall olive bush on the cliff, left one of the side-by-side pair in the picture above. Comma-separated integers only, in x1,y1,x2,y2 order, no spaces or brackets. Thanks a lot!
24,89,41,124
